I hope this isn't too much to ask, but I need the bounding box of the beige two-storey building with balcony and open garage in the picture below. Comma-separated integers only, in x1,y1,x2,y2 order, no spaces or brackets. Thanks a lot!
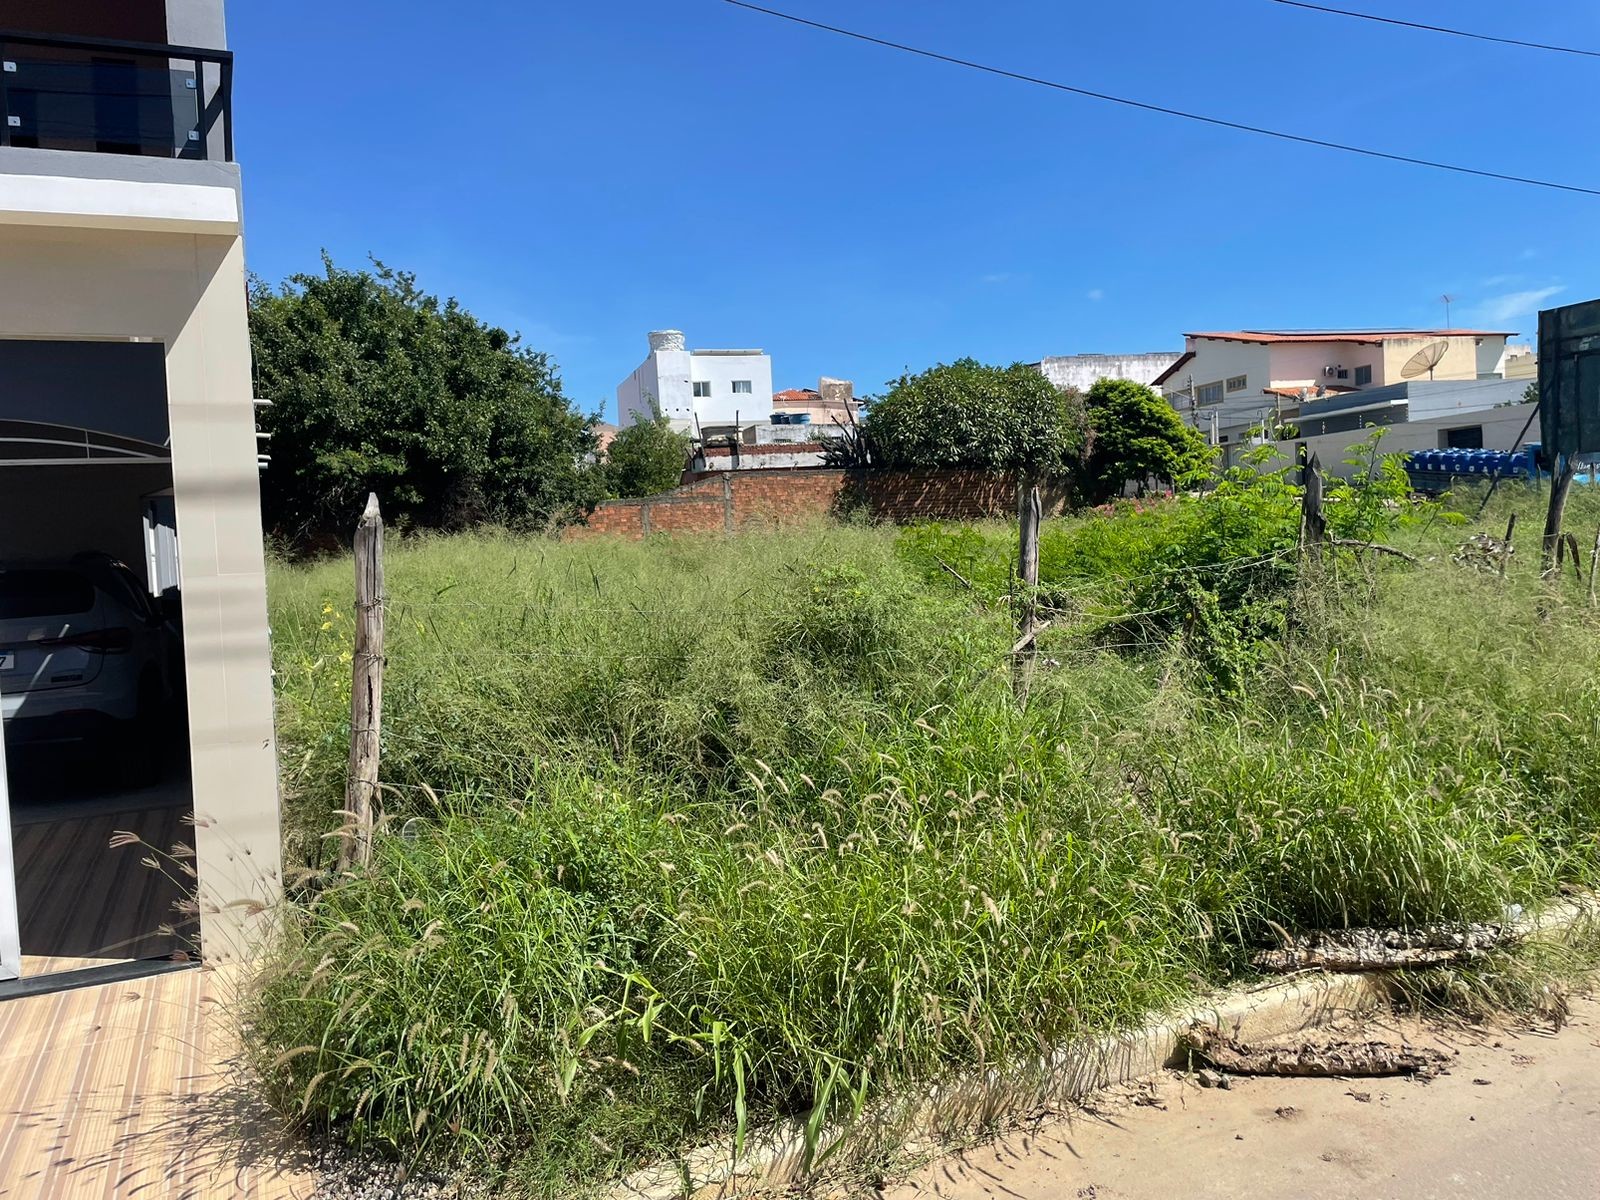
0,0,280,992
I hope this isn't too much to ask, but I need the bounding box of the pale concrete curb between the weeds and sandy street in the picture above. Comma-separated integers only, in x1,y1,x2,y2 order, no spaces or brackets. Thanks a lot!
605,899,1600,1200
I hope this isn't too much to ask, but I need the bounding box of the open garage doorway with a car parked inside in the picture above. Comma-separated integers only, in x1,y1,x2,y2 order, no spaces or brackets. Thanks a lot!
0,341,198,978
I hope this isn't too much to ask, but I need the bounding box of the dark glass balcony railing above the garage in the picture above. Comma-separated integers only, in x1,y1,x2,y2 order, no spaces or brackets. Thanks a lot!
0,30,234,162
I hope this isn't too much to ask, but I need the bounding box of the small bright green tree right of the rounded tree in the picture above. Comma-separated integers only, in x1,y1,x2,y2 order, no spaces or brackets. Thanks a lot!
1083,379,1211,502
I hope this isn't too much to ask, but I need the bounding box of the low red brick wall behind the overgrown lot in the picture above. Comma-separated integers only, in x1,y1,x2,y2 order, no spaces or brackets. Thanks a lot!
570,467,1064,538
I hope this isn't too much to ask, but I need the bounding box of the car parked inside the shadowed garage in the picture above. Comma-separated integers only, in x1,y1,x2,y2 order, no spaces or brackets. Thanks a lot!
0,554,178,784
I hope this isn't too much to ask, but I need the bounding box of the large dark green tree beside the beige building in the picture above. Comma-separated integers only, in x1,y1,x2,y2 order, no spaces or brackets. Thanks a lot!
250,254,605,547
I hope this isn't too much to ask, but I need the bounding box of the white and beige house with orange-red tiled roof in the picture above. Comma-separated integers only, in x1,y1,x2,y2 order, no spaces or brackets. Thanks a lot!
1152,330,1514,443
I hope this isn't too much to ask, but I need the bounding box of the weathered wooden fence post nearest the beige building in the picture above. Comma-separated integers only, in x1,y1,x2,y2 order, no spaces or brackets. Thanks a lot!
339,494,384,870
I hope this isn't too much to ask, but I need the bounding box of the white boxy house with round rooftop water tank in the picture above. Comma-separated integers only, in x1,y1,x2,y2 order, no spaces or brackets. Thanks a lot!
616,330,773,432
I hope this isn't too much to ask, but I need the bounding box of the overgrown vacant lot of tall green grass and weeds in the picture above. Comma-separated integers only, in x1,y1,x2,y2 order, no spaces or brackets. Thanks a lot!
259,464,1600,1194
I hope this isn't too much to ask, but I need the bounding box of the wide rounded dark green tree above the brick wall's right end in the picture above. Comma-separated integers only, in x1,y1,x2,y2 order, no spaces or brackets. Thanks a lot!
861,358,1086,475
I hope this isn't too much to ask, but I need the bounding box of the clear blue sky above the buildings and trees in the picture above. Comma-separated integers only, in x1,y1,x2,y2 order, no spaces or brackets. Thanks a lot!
229,0,1600,414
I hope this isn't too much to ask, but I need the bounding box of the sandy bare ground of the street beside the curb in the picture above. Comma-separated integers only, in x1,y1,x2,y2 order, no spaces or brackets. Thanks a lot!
885,1000,1600,1200
